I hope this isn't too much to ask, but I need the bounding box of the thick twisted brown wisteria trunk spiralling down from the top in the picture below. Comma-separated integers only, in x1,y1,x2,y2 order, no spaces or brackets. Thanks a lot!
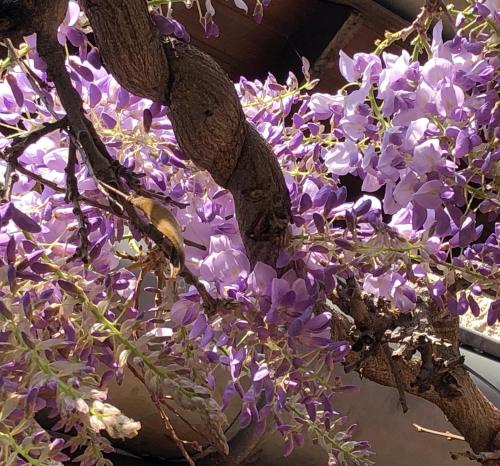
83,0,291,265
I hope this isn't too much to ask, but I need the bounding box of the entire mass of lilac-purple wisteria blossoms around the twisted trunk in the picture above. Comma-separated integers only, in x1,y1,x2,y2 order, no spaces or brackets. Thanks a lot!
0,1,500,465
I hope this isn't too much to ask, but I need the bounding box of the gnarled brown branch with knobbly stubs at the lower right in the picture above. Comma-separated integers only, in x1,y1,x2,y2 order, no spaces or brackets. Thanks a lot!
330,283,500,466
